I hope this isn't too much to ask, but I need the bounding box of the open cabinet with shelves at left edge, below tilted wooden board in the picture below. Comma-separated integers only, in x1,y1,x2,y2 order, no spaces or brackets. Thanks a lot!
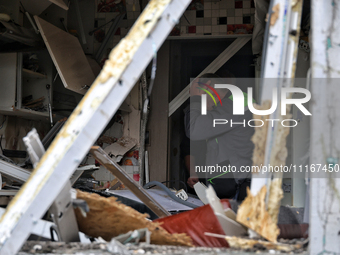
0,49,52,121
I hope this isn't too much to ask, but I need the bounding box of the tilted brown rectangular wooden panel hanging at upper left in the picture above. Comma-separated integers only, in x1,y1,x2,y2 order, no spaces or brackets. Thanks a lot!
34,16,95,94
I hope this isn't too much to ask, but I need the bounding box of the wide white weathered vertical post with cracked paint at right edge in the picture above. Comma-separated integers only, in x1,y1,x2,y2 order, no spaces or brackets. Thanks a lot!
309,0,340,254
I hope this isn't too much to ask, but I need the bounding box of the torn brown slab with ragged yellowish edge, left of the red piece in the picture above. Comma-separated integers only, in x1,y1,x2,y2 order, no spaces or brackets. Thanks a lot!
76,191,192,246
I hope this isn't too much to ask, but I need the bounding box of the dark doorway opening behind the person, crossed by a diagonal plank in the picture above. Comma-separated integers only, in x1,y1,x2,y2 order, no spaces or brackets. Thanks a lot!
168,38,255,192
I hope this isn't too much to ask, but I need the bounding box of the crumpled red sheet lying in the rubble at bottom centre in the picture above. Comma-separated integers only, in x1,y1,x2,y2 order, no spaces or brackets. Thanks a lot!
154,199,231,247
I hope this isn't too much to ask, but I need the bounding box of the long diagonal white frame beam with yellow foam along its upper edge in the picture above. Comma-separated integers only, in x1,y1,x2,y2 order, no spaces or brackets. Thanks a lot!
0,0,190,255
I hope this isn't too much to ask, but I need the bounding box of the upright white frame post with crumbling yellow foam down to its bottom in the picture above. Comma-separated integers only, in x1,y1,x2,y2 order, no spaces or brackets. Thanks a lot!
238,0,303,242
